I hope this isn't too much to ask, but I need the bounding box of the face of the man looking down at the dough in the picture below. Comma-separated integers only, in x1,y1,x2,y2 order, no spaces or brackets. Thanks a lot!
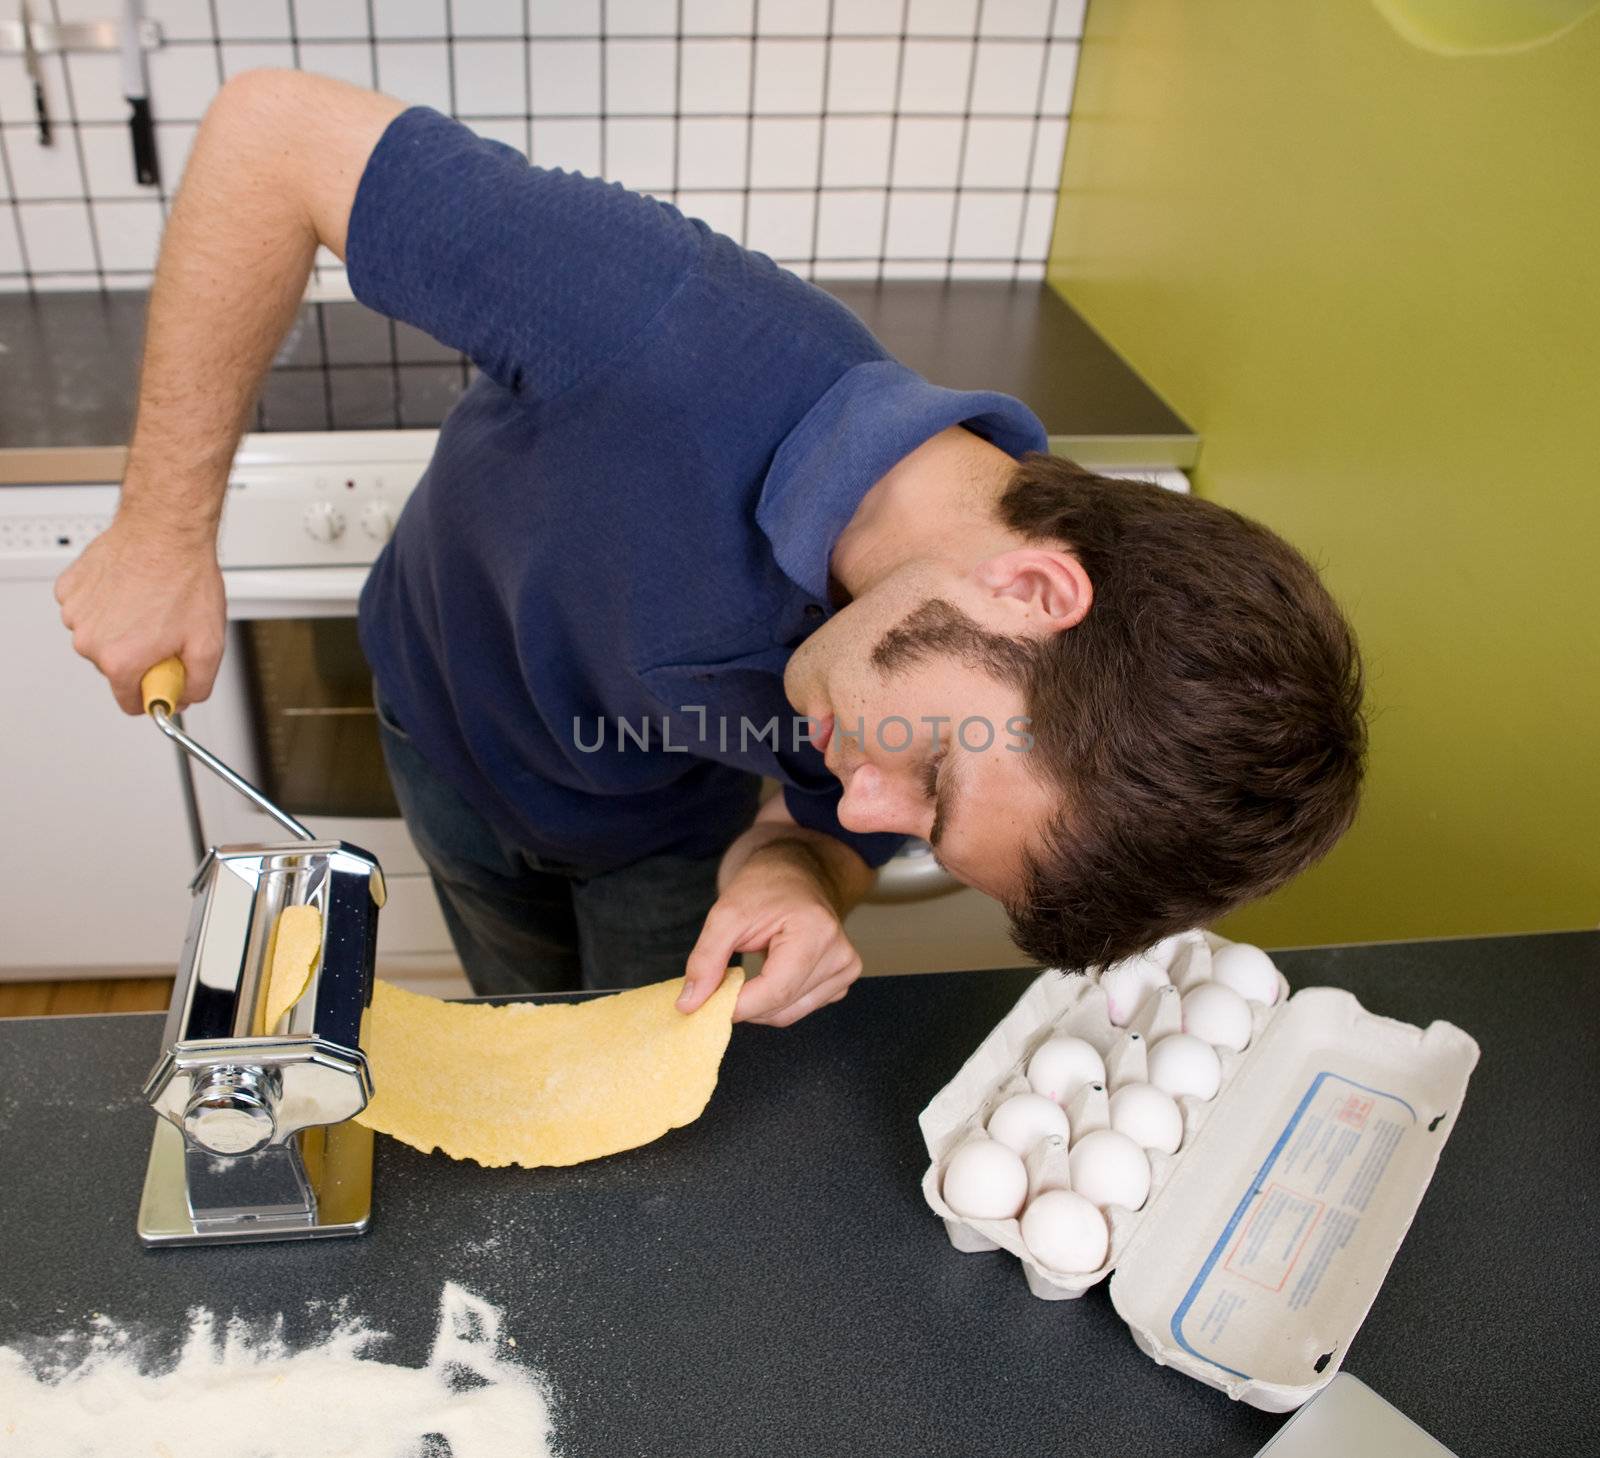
784,579,1054,899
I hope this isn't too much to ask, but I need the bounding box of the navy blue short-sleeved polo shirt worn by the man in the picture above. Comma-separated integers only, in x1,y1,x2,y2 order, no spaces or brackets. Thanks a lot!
347,107,1046,869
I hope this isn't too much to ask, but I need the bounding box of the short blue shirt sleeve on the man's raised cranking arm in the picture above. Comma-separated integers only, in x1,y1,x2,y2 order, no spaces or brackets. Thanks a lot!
346,107,707,400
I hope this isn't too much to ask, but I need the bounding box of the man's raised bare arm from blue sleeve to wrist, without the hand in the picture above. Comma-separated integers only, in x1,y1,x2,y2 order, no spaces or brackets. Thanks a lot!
123,72,400,539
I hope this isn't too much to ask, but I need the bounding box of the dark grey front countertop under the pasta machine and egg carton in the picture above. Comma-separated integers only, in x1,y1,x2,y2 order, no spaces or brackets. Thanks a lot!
0,933,1600,1458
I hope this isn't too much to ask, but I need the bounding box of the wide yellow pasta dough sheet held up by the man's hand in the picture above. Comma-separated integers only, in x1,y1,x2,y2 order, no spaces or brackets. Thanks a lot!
357,970,744,1168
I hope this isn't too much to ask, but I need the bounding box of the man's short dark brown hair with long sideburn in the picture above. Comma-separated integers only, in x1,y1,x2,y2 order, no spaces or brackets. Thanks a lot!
872,455,1366,967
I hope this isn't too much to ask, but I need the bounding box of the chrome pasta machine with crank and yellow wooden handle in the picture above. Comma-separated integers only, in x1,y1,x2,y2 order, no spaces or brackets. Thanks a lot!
139,658,384,1245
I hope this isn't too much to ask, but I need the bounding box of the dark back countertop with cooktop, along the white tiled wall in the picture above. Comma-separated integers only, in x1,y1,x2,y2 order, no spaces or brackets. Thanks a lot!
0,282,1197,480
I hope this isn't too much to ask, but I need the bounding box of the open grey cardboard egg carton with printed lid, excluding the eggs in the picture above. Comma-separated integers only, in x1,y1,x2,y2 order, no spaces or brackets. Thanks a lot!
918,930,1478,1412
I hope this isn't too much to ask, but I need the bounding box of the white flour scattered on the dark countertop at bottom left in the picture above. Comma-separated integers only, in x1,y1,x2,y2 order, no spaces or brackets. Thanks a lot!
0,1282,557,1458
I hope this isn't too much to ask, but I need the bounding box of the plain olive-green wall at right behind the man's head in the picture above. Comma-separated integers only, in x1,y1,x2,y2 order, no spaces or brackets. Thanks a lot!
1051,0,1600,946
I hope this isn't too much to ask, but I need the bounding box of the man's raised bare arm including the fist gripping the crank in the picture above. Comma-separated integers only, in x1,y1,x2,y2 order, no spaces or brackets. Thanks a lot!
56,70,402,714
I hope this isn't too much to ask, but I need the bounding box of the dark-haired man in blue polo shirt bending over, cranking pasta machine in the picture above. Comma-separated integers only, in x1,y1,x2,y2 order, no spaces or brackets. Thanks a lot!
58,72,1363,1024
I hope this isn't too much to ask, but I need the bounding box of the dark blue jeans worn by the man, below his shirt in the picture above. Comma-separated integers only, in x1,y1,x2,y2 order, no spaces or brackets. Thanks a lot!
376,699,722,995
